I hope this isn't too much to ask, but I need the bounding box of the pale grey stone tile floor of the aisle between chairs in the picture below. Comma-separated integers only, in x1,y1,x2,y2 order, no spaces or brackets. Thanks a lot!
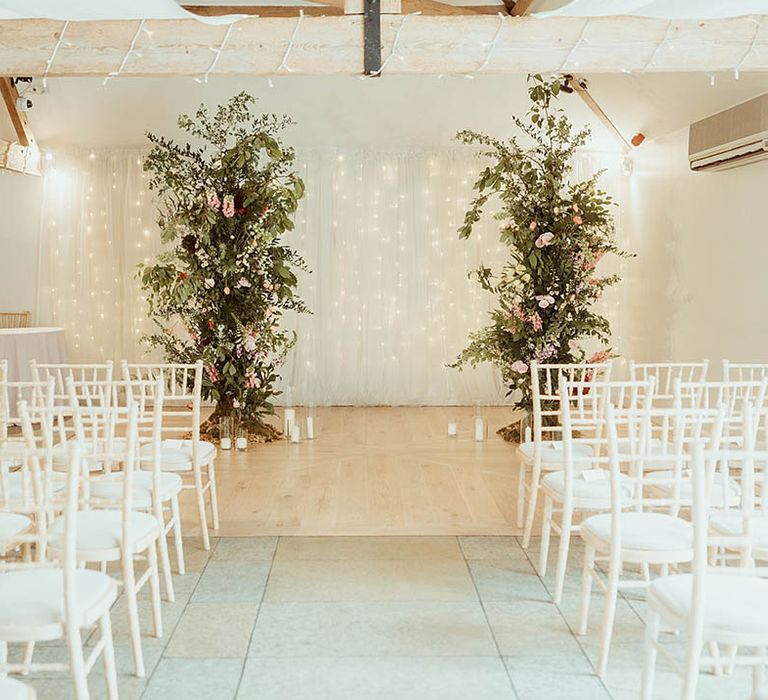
18,537,749,700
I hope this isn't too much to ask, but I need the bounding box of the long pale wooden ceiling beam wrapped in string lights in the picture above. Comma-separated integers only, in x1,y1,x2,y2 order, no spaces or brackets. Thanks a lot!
0,16,768,76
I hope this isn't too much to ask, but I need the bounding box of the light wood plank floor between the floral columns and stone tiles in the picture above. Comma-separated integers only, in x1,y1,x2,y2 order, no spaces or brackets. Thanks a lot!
182,407,517,537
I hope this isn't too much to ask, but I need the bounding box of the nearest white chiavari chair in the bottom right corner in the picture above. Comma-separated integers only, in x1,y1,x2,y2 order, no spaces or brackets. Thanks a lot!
641,405,768,700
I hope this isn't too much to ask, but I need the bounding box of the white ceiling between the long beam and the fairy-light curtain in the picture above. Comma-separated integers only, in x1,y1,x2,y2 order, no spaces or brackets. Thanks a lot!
22,73,768,149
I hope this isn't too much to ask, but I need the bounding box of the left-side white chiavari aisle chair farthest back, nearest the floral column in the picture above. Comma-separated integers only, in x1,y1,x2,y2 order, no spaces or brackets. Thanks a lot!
123,362,219,550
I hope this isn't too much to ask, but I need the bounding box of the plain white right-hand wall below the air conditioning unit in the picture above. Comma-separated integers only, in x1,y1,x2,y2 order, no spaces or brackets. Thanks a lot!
626,130,768,376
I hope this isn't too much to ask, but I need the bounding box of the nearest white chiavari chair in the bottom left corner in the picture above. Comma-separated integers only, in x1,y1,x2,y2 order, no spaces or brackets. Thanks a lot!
0,403,118,700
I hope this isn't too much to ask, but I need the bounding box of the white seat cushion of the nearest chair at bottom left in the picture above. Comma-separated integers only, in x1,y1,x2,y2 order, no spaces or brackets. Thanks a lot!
0,569,117,641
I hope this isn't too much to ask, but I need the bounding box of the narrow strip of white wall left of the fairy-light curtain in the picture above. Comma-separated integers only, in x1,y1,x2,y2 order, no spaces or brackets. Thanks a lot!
0,170,43,323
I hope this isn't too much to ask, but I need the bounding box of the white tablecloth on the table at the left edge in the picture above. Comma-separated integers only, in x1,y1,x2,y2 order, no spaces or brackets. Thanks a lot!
0,327,67,414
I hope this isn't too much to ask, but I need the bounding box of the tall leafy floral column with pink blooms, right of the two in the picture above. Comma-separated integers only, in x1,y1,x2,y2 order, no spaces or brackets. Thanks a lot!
452,75,627,410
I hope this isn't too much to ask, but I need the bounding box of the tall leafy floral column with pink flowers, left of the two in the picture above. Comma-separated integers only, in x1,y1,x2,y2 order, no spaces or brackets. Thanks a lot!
139,92,307,422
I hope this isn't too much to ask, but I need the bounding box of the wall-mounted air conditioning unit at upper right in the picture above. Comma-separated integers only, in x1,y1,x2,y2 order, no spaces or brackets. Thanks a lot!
688,94,768,172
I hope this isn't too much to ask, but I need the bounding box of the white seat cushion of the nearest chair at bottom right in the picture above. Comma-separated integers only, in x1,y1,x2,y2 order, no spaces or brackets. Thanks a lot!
648,574,768,641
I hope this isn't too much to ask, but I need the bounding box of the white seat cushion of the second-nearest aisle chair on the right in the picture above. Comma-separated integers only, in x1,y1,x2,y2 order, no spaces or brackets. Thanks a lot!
581,512,693,552
